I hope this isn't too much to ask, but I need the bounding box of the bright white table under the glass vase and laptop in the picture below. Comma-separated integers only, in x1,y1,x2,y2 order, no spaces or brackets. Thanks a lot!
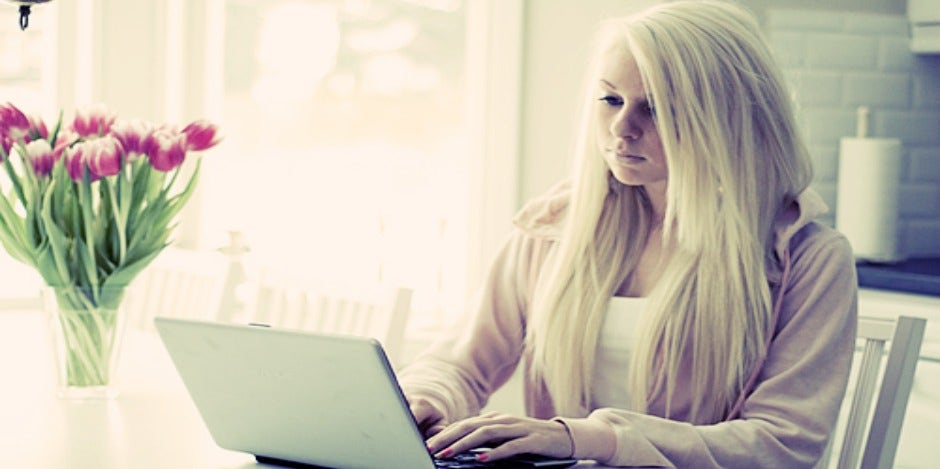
0,311,604,469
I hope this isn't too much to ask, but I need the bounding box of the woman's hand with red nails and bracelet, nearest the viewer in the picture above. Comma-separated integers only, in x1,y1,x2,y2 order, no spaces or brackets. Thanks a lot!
427,413,574,461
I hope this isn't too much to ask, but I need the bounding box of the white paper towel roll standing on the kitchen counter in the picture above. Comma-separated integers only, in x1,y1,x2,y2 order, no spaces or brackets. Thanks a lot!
836,138,901,262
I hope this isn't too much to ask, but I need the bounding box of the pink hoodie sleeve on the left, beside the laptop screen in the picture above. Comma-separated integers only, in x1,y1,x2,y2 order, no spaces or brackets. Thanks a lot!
399,229,540,423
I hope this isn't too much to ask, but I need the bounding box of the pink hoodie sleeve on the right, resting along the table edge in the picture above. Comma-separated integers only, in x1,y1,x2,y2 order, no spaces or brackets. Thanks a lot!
559,227,857,468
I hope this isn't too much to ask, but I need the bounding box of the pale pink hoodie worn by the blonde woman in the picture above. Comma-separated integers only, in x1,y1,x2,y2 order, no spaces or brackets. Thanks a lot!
400,184,857,468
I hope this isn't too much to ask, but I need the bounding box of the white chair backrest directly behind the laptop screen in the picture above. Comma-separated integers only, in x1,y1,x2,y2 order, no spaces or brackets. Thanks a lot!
250,283,412,364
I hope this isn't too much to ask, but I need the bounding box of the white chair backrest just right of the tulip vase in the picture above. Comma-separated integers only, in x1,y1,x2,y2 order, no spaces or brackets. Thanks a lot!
128,247,229,330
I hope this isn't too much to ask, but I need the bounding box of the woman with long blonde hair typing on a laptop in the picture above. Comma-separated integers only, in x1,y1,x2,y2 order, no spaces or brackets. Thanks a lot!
401,1,857,468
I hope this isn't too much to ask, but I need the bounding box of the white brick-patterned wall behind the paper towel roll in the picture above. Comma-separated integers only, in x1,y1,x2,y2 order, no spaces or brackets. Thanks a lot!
766,9,940,257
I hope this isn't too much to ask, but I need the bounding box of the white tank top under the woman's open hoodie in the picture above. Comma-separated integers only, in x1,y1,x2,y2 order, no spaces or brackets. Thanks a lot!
591,296,647,409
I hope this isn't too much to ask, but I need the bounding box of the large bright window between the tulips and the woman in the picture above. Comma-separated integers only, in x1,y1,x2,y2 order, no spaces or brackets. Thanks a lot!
199,0,518,324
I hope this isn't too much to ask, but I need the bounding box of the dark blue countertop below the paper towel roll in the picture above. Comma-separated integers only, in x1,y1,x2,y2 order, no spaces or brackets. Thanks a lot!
856,257,940,297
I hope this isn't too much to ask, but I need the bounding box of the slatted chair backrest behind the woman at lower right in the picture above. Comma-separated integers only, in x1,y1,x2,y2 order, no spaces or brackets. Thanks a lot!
817,316,927,469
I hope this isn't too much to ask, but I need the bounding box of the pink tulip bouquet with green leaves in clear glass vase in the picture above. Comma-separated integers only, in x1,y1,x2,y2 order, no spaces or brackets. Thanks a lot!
0,103,218,394
